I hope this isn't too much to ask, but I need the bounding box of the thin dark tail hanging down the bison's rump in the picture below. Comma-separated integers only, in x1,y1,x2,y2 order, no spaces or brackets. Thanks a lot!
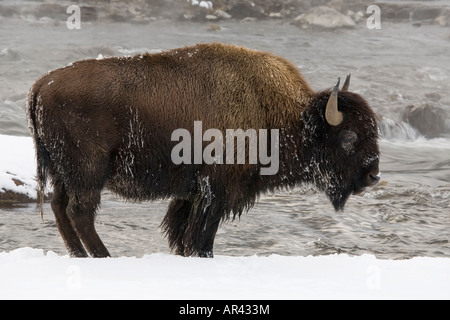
27,85,50,219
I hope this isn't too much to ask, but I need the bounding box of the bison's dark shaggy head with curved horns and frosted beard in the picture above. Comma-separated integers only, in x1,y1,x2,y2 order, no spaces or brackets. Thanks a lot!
302,75,380,210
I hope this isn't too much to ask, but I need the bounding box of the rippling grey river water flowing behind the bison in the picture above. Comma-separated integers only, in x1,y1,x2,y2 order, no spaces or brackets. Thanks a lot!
0,18,450,259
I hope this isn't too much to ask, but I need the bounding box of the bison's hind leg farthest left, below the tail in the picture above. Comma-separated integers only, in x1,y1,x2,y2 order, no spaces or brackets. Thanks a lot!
52,183,88,258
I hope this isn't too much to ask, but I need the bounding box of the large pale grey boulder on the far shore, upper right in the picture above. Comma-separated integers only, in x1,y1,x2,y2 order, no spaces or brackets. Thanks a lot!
293,6,356,29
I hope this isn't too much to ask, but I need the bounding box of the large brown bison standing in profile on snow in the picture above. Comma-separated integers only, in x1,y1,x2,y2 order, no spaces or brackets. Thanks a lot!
27,43,379,257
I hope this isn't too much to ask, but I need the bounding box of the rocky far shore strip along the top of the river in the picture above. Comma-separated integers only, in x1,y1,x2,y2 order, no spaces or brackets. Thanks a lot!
0,0,450,30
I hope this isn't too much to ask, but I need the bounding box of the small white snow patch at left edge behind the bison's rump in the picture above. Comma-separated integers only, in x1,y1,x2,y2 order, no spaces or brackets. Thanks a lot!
0,135,37,199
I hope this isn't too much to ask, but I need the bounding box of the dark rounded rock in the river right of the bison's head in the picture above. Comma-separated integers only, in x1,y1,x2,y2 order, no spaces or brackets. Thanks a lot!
403,103,450,138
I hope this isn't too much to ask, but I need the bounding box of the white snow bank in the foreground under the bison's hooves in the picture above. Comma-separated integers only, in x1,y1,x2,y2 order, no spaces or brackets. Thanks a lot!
0,248,450,300
